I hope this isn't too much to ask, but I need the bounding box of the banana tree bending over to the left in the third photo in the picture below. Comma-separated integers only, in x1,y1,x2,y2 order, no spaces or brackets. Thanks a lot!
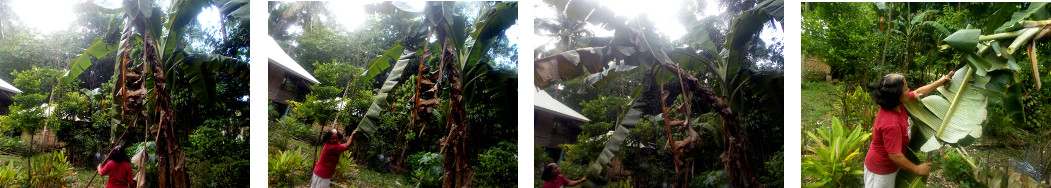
534,0,783,187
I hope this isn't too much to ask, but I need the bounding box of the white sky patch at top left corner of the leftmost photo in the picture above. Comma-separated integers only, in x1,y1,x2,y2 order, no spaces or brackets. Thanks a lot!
11,0,77,34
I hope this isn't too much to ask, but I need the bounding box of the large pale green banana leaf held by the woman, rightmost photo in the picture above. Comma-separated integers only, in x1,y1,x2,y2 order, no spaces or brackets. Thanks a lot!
905,66,988,151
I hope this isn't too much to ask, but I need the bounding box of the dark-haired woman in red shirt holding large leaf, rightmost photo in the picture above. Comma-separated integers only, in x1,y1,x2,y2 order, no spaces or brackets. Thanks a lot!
865,71,955,188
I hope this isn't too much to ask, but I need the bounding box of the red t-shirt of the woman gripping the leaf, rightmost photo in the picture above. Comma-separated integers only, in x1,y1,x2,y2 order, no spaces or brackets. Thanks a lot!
865,91,916,174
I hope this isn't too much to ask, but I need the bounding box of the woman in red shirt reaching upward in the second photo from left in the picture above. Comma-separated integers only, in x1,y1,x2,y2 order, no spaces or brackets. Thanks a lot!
310,128,357,188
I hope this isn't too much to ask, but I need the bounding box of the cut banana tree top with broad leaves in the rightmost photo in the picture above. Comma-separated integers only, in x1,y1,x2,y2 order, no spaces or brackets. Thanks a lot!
904,2,1051,186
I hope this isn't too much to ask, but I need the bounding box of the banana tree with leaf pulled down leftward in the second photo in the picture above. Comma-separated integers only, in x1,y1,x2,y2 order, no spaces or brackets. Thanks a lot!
356,2,518,187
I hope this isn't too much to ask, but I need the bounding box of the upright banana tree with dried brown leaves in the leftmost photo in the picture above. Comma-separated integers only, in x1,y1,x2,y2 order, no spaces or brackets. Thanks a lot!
61,0,248,187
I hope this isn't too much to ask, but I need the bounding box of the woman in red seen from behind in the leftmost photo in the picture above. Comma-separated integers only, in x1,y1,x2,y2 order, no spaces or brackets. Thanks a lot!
96,146,133,188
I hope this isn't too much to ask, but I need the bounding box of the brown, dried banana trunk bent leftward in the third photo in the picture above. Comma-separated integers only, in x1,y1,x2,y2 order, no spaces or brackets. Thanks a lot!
662,64,765,187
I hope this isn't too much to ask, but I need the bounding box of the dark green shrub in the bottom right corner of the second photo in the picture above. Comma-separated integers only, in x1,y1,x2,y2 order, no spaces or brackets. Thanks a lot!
472,141,518,187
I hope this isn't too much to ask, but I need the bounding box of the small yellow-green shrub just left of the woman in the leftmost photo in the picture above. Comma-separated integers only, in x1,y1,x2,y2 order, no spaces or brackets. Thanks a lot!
26,151,74,187
